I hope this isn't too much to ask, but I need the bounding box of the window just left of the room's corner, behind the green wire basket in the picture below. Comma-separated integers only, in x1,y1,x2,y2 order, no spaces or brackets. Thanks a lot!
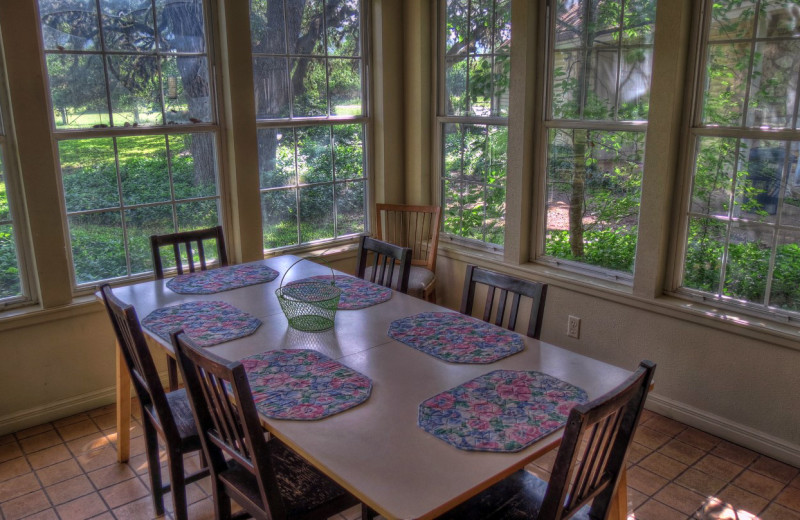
250,0,367,249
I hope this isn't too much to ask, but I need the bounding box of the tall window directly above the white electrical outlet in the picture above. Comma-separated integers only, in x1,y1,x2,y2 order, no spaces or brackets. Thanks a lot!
544,0,656,277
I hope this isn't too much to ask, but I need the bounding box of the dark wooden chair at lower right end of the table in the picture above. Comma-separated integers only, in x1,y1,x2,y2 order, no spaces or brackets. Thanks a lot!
440,361,656,520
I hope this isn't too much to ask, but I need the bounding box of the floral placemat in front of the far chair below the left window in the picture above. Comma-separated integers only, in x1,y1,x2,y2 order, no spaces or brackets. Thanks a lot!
167,264,278,294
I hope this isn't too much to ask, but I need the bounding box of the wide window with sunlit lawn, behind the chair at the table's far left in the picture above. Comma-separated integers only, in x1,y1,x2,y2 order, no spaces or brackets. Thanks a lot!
39,0,220,286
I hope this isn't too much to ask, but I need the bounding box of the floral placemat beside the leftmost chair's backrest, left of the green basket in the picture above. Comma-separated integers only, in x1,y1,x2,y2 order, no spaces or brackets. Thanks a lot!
142,301,261,347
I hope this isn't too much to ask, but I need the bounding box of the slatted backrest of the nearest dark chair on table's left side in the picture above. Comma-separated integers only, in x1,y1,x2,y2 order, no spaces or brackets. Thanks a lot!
172,331,286,518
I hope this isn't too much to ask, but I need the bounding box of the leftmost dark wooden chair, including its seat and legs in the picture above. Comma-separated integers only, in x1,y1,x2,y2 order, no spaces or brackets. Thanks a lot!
100,284,209,520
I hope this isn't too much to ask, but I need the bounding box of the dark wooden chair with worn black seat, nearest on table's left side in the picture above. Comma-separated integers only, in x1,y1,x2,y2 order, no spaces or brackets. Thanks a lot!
172,332,366,520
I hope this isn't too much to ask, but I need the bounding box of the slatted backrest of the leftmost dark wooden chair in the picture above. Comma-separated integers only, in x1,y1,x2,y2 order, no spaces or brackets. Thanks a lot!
100,284,180,439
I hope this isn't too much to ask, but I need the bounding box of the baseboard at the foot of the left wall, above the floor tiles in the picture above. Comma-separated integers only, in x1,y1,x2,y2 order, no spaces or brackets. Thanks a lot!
0,386,116,435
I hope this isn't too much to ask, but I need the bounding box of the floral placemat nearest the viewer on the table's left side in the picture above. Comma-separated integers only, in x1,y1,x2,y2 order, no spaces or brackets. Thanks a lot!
242,349,372,421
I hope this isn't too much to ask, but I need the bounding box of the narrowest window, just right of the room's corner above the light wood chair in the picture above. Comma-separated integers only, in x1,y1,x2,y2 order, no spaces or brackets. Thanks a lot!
437,0,511,246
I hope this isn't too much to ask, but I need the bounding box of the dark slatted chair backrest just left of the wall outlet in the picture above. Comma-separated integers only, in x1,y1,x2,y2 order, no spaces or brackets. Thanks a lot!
460,265,547,339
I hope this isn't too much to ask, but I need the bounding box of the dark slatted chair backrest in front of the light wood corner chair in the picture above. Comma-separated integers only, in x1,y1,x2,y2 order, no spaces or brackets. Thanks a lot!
356,236,411,293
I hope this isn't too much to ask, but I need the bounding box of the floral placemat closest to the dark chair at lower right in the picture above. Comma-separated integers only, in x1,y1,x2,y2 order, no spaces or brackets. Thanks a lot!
418,370,588,452
